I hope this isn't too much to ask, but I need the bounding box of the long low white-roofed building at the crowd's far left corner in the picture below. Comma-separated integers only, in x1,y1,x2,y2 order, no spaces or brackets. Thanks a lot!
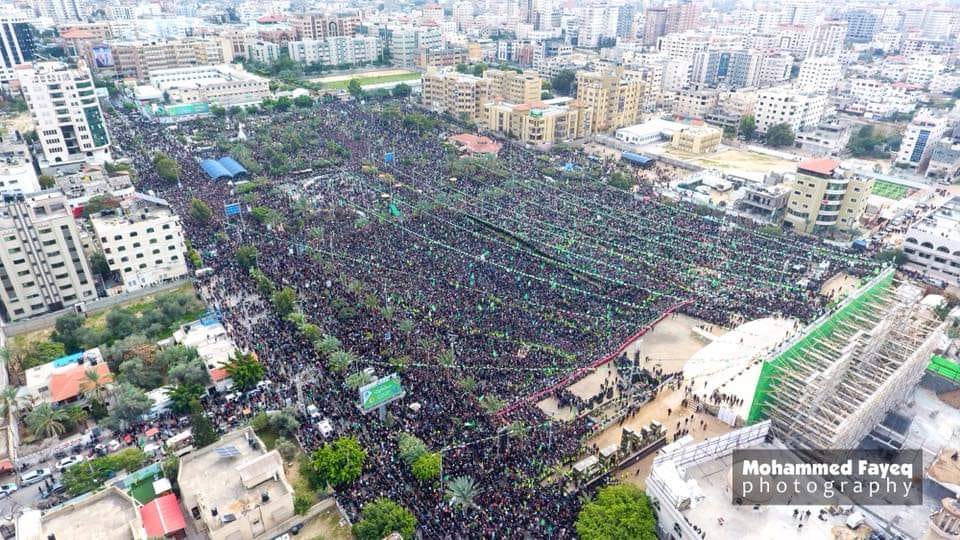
150,64,270,107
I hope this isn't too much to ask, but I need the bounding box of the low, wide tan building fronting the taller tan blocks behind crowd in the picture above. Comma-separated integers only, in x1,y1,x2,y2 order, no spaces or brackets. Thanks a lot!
484,98,593,145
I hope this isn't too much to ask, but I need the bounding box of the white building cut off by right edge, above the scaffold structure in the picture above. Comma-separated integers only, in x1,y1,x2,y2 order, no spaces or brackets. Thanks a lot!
903,197,960,284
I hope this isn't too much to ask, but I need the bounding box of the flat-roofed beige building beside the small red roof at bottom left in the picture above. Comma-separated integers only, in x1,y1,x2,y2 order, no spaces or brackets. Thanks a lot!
177,427,294,540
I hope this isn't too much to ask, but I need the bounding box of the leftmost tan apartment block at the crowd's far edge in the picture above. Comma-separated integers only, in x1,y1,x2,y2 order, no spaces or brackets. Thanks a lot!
421,69,490,122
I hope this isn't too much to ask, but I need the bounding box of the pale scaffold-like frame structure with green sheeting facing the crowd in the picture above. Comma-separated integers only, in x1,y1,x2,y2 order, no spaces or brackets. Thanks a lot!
750,269,946,449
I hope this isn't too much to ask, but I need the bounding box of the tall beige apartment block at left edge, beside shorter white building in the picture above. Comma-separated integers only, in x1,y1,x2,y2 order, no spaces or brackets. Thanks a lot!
0,190,97,321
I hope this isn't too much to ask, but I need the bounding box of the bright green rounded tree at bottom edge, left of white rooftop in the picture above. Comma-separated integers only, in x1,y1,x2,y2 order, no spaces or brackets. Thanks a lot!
576,484,657,540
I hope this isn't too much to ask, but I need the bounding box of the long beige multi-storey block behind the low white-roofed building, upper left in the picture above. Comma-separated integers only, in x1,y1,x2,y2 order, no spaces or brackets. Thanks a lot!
110,37,234,82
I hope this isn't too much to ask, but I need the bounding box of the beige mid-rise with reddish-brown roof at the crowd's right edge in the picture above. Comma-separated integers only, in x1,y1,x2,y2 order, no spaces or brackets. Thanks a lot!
784,158,873,234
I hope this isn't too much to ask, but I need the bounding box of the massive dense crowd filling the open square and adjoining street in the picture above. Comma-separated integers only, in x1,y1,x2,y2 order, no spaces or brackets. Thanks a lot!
110,98,875,537
